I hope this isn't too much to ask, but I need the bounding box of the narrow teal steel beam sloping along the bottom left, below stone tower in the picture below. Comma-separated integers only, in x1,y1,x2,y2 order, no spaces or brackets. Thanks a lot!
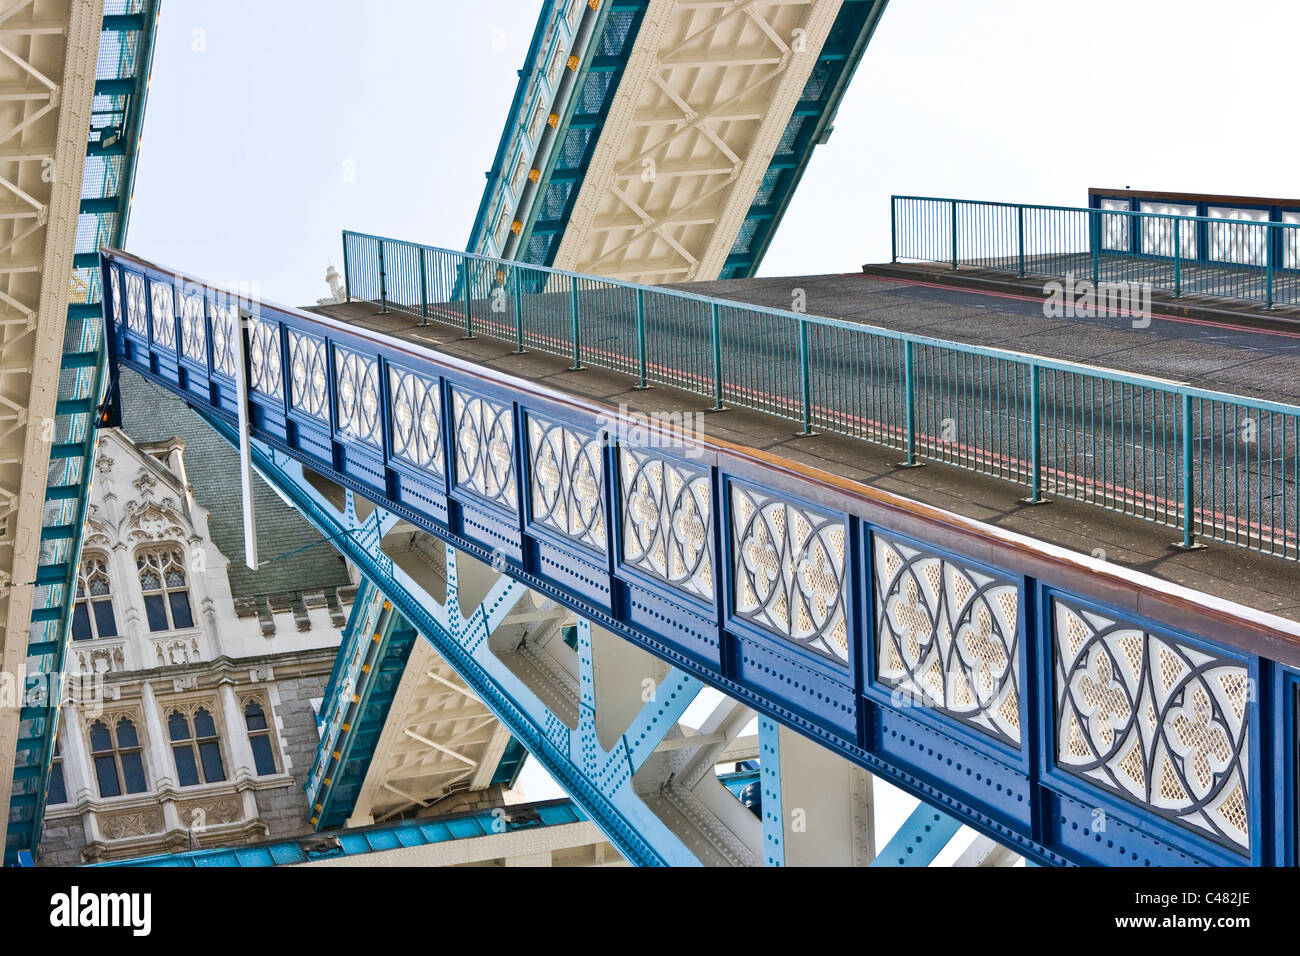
95,800,586,869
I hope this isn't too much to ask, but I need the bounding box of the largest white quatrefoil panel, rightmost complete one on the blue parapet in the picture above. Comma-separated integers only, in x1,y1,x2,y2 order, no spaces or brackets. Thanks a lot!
1052,598,1251,848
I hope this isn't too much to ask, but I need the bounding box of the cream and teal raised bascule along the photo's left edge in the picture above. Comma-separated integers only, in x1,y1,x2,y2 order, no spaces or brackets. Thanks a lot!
0,0,157,864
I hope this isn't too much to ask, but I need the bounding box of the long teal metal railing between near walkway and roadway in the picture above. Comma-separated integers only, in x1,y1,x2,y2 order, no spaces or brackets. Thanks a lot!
343,230,1300,559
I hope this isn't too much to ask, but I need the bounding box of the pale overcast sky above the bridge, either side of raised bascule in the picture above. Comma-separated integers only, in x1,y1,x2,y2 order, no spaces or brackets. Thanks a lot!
127,0,1300,304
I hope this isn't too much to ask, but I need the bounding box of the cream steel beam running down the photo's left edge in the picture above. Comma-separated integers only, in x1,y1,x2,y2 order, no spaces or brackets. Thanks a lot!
0,0,104,842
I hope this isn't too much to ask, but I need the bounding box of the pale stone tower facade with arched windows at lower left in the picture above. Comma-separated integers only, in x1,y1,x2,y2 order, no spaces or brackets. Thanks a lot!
38,421,355,865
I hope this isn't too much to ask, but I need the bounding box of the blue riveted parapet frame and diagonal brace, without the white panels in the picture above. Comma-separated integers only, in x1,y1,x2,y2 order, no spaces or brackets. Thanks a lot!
98,252,1300,865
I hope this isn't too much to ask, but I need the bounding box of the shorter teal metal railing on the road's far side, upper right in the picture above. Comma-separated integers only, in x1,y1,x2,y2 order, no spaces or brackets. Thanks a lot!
889,196,1300,308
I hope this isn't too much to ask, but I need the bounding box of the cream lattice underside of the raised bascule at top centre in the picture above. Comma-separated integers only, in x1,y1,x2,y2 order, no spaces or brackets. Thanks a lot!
554,0,841,284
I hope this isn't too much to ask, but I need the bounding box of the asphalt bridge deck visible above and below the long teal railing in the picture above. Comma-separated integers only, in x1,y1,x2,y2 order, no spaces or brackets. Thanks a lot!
311,295,1300,629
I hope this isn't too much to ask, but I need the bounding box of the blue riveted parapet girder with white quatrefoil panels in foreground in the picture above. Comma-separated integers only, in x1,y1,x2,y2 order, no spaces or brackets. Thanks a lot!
105,252,1300,865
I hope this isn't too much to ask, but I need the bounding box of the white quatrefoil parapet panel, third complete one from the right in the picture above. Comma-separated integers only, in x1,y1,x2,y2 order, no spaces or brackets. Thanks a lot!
731,484,849,663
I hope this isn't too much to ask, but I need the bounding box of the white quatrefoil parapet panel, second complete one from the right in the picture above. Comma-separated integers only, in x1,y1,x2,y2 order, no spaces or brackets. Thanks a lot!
871,533,1022,747
